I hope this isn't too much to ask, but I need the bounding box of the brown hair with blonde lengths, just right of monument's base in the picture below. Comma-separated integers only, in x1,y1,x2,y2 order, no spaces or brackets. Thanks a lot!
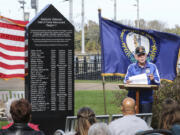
76,107,96,135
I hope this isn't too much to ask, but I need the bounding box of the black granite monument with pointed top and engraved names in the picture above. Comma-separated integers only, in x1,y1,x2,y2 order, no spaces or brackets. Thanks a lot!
25,5,74,135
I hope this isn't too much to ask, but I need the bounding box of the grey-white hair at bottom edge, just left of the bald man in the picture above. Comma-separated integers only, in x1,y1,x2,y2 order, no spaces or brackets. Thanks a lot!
88,123,111,135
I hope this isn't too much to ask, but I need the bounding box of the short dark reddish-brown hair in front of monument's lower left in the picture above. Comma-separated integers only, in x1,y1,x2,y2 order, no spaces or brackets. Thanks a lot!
10,99,31,123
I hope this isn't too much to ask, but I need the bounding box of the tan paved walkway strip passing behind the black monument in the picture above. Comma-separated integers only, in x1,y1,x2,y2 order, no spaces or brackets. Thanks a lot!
0,79,119,90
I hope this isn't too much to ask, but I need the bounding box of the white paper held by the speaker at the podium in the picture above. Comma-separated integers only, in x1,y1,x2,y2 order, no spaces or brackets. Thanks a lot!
129,73,148,84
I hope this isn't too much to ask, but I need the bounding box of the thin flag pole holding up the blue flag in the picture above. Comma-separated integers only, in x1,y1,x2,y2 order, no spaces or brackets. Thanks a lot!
98,9,107,114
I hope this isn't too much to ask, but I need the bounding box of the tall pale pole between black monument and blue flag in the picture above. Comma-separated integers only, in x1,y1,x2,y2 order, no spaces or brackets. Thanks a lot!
81,0,85,54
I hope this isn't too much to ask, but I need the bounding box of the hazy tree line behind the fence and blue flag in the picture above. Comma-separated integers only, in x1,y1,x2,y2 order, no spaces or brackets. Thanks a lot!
75,19,180,53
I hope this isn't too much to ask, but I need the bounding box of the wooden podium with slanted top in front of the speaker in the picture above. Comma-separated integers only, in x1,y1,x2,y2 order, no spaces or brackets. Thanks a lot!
119,84,158,113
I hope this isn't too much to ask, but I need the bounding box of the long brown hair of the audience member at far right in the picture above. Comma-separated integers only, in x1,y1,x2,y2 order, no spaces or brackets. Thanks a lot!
159,98,177,129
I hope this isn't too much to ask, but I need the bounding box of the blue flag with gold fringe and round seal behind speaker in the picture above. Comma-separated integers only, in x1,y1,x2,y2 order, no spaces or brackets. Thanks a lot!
99,13,180,80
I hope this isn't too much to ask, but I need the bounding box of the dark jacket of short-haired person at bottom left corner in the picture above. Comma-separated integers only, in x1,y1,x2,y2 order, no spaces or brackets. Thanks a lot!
0,123,44,135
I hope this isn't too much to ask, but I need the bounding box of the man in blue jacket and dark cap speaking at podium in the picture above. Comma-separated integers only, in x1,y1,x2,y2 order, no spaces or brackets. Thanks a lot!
124,46,160,113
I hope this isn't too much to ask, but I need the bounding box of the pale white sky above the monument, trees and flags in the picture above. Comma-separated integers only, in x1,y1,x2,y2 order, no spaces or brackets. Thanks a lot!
0,0,180,28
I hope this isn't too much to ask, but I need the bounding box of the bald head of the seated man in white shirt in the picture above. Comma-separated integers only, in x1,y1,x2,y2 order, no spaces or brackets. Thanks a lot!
121,97,136,115
